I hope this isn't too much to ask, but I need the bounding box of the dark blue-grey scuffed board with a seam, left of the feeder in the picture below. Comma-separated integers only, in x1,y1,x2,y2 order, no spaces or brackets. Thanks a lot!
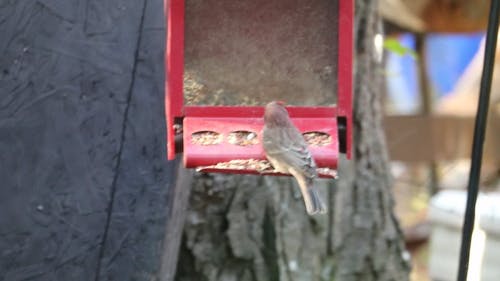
0,0,175,281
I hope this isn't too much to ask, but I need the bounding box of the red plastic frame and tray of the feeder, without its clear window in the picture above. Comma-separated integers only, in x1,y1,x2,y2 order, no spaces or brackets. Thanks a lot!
165,0,353,177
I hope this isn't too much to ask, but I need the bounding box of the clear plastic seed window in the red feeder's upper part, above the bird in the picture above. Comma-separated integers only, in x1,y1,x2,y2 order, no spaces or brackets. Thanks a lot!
184,0,338,105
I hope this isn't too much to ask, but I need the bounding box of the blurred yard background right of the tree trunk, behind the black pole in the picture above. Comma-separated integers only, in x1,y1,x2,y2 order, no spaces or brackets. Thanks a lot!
379,0,500,281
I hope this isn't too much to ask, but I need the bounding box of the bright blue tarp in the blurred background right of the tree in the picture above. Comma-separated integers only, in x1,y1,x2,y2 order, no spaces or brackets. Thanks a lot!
386,33,484,113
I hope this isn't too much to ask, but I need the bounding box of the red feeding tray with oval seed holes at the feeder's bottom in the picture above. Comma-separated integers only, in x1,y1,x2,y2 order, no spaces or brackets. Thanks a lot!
183,106,339,177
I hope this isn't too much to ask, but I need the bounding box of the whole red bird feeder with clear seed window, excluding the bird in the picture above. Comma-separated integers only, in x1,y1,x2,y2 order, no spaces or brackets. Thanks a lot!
165,0,353,177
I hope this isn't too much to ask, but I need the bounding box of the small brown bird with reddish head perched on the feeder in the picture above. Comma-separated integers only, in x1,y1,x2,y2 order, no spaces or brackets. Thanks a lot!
262,101,326,215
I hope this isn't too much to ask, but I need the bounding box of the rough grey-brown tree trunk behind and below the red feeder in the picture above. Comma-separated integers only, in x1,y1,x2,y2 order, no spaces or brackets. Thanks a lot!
175,0,409,281
